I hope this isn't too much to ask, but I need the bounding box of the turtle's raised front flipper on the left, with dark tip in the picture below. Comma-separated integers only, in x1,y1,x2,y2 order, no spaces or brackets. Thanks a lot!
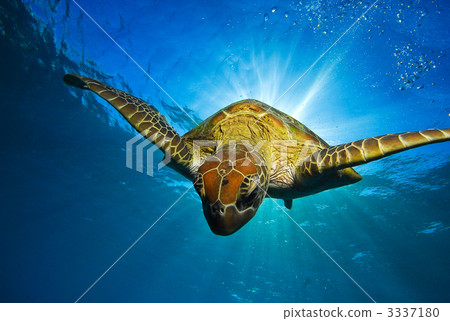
63,74,192,179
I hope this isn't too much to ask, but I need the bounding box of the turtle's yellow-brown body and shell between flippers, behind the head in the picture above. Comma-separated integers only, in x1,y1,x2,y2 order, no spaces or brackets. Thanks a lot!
183,99,361,200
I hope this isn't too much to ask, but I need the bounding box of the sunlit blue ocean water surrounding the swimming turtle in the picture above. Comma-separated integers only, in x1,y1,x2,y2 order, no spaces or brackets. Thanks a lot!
0,0,450,302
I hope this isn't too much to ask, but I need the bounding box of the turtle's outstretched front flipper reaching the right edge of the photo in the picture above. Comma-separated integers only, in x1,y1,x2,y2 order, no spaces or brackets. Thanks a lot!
297,128,450,177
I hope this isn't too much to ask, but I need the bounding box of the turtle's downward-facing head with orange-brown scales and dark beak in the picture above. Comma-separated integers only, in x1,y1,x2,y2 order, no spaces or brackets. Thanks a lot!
194,145,268,236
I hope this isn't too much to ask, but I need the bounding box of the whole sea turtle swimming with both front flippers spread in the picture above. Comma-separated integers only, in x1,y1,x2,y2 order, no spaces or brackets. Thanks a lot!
64,74,450,235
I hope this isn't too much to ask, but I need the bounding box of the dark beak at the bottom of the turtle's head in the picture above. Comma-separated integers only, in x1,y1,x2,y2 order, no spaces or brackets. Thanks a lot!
203,200,257,236
